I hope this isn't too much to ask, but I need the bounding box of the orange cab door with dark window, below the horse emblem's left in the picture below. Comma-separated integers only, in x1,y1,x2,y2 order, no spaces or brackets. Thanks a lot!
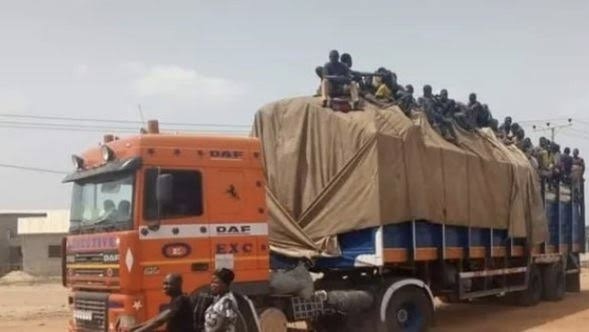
138,167,213,315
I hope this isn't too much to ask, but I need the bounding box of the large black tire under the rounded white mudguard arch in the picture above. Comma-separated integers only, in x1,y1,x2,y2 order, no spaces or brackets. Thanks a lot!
380,286,433,332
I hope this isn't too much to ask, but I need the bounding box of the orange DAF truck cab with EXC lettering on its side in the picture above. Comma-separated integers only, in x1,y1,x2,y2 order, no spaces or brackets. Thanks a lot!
63,123,269,331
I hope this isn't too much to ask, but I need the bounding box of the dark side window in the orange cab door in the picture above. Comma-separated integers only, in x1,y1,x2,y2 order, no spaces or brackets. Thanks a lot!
143,168,203,220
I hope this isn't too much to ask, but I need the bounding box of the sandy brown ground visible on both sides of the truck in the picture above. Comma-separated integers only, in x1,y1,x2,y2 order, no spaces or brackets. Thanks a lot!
0,270,589,332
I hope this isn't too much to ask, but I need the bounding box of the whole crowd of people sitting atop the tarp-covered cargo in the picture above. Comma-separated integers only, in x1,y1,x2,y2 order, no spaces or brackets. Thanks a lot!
315,50,585,194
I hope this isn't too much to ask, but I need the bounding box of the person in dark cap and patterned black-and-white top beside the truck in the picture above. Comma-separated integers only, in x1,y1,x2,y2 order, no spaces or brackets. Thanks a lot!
204,268,243,332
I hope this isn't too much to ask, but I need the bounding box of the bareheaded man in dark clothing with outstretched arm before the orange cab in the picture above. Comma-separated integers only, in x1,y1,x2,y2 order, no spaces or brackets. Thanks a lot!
131,273,193,332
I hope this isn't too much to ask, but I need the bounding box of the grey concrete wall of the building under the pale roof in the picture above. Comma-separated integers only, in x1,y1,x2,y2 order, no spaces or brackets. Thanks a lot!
20,234,65,276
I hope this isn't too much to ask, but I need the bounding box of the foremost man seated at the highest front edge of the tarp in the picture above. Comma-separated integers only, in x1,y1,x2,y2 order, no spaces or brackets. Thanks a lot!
321,50,359,109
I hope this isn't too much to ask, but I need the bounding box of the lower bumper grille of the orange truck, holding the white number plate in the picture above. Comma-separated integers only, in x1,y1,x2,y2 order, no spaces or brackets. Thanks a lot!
74,292,108,332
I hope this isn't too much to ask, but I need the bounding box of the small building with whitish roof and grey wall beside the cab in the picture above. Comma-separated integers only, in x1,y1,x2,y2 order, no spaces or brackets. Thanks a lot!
18,210,70,276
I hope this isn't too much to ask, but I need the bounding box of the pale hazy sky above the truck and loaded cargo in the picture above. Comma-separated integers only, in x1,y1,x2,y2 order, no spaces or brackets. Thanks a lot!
0,0,589,209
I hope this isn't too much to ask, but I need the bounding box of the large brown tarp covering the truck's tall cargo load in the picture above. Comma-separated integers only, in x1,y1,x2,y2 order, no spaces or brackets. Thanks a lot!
253,97,547,257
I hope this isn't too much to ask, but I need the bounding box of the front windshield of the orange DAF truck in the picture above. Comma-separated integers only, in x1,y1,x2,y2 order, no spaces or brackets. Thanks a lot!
70,174,134,233
